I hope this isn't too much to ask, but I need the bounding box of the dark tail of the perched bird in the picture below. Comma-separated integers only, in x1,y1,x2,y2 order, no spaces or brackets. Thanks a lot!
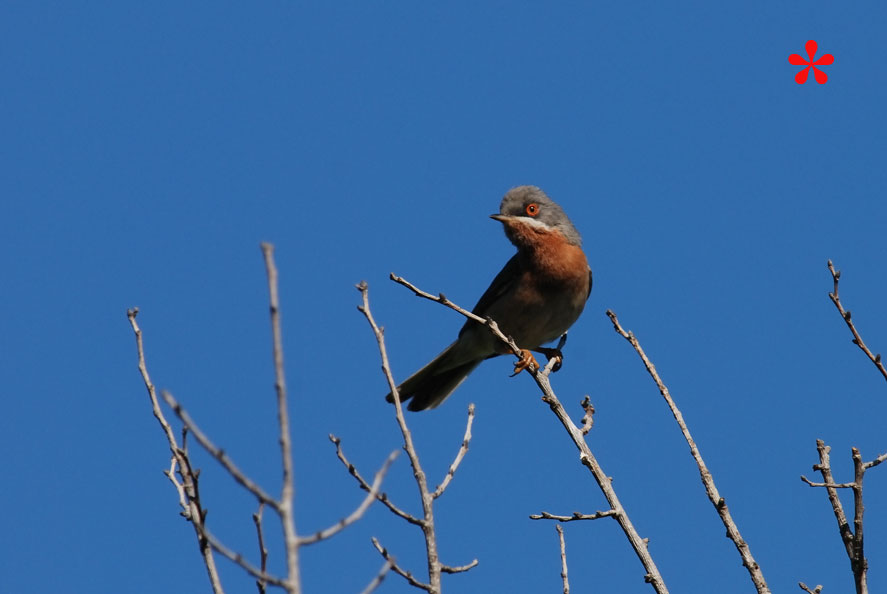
385,342,483,410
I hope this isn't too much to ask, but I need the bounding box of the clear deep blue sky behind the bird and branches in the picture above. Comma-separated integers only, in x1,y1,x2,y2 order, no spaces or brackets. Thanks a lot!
0,1,887,594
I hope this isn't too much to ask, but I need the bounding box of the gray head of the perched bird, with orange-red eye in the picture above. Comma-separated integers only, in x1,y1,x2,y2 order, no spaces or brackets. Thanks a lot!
490,186,582,245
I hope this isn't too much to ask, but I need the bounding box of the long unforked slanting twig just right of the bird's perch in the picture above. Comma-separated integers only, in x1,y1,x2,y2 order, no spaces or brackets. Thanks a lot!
607,309,770,594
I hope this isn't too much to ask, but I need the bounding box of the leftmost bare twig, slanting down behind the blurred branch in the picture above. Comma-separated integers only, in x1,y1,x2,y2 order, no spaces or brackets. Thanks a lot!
126,307,224,594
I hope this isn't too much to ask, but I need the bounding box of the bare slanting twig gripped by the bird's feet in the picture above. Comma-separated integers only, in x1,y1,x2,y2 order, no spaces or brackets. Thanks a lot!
394,274,668,594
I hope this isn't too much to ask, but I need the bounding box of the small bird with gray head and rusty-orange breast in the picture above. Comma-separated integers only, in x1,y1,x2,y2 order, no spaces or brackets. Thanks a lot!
386,186,592,411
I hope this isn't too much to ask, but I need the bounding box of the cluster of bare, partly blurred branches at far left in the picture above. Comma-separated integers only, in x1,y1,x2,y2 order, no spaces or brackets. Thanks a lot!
127,243,398,594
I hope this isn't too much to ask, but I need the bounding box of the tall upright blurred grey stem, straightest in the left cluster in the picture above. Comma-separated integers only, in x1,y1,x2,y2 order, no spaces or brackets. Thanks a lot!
262,243,302,594
